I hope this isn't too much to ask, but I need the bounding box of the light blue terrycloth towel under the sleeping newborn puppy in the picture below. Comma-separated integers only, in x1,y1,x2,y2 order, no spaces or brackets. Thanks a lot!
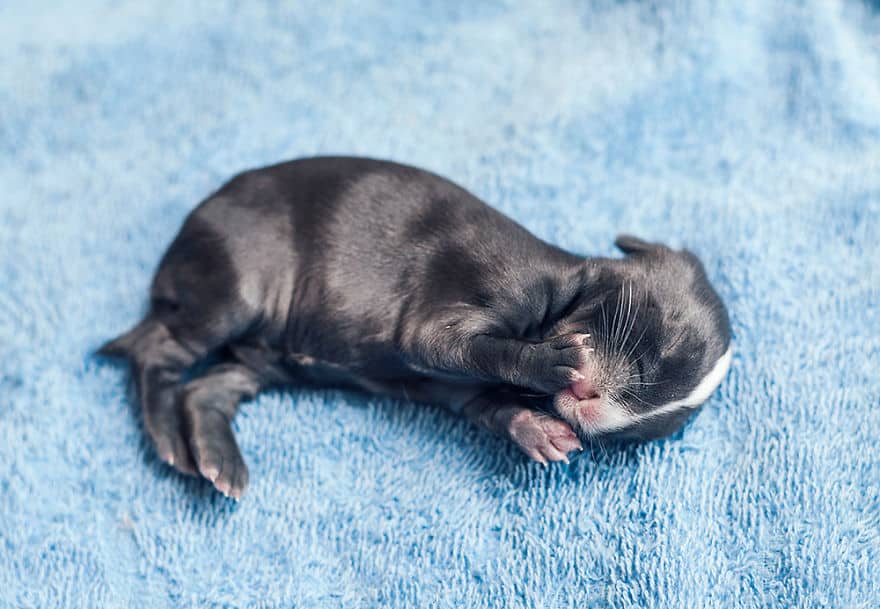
0,0,880,608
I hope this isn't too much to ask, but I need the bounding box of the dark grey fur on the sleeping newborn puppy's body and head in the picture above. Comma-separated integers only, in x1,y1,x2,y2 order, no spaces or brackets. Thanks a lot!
101,158,730,497
